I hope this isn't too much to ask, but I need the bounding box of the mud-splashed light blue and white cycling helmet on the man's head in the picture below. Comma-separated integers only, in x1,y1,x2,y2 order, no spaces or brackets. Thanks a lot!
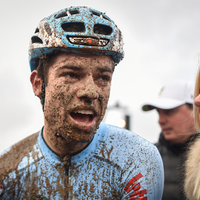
29,6,124,71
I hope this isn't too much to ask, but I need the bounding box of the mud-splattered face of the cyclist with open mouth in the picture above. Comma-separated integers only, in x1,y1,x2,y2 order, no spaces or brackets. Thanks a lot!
44,53,114,144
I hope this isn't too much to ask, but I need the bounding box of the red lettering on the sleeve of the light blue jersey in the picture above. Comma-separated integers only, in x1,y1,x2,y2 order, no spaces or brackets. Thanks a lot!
124,173,147,200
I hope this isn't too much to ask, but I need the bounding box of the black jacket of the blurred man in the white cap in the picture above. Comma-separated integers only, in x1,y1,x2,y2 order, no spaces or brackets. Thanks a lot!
155,133,198,200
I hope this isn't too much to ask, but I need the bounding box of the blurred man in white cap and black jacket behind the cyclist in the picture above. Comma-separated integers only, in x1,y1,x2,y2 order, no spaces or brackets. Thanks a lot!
142,80,197,200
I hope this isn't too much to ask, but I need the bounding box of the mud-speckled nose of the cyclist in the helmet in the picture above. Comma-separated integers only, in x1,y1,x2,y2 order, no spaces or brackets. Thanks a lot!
77,75,99,99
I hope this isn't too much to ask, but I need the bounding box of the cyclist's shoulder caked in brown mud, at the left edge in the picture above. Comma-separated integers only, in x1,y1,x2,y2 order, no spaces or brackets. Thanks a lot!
0,132,39,178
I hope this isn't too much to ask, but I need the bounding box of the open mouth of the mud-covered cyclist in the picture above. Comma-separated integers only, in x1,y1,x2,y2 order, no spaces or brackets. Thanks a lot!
70,110,95,124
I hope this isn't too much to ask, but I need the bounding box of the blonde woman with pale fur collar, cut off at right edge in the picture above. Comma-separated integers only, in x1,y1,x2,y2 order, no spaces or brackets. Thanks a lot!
184,68,200,200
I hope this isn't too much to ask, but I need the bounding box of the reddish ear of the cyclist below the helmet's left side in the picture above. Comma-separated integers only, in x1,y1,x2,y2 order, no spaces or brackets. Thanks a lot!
30,70,42,99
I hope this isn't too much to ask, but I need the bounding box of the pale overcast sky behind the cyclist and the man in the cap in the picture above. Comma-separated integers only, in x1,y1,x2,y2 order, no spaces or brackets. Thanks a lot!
0,0,200,152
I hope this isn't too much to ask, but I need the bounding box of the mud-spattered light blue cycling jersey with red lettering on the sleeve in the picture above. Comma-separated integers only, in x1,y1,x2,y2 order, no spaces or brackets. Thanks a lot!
0,123,164,200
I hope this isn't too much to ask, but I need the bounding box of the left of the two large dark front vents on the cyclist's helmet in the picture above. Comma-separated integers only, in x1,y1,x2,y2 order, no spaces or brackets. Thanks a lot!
62,22,85,32
